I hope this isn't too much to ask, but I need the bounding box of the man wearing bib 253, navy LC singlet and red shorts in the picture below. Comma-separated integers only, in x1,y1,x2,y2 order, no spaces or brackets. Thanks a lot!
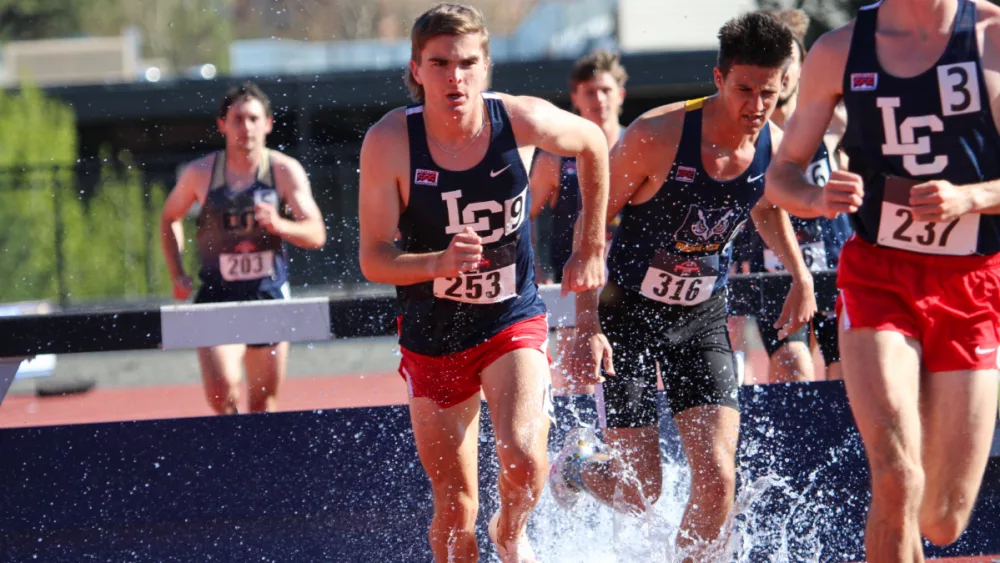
360,4,608,563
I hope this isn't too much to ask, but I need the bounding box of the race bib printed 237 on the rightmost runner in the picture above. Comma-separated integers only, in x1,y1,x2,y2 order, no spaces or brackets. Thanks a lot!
878,176,979,256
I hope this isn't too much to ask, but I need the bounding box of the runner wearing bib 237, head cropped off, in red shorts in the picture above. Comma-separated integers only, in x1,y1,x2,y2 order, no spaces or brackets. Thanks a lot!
768,0,1000,563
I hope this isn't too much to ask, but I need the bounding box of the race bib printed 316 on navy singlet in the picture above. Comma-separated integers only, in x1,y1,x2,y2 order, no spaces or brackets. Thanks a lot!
641,249,719,307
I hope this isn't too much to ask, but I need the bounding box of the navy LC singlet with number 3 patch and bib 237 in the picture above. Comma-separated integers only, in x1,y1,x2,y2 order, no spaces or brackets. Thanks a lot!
843,0,1000,255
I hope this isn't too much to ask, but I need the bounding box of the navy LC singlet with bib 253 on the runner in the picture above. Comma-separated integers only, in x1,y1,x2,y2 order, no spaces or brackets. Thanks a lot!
396,93,545,356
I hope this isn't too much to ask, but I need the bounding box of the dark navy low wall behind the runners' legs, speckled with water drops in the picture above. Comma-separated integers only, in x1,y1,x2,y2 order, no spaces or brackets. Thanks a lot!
0,382,1000,563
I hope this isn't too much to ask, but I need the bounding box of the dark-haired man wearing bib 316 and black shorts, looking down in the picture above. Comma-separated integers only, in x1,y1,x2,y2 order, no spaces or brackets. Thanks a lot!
550,13,816,560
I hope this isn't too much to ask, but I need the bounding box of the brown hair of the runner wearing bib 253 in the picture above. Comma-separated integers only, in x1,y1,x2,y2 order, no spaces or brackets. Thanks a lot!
403,4,490,104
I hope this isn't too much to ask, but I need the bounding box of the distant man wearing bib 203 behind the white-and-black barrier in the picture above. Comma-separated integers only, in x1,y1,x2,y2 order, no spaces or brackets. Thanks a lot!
160,83,326,414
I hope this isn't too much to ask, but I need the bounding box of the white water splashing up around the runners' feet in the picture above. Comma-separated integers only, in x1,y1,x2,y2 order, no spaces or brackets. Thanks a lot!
528,432,850,563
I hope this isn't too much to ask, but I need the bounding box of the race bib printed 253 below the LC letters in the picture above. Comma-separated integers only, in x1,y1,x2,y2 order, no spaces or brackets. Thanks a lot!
434,242,517,305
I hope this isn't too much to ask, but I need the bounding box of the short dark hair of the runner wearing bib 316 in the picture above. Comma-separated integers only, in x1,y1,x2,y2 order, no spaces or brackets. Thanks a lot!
719,12,792,76
